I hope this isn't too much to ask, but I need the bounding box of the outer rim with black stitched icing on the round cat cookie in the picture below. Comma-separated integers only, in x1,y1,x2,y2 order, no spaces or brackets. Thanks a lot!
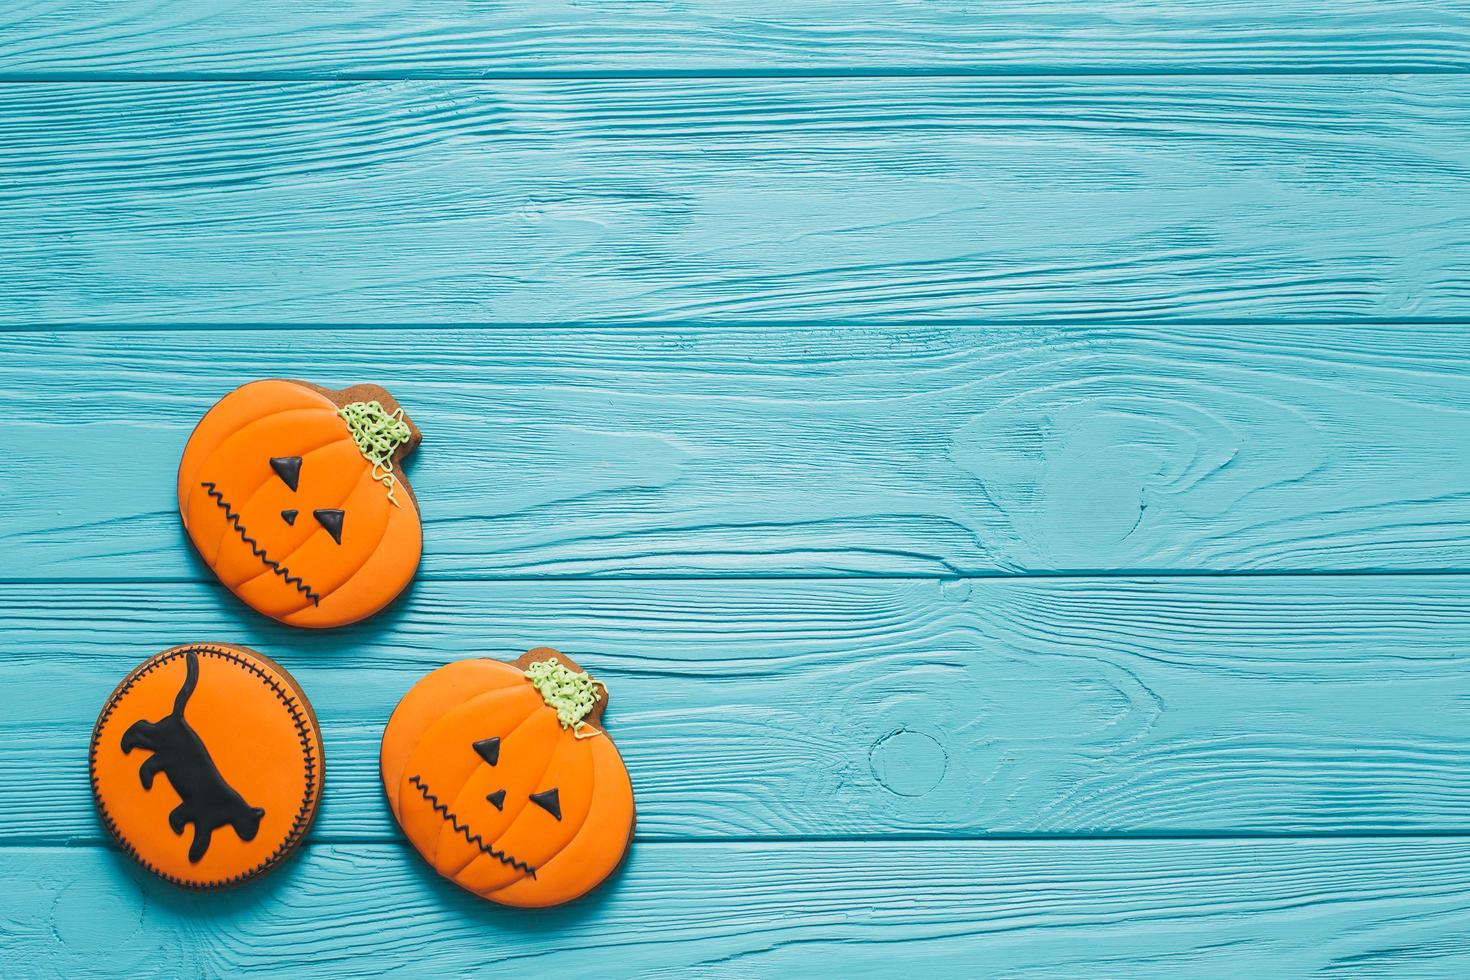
88,644,318,889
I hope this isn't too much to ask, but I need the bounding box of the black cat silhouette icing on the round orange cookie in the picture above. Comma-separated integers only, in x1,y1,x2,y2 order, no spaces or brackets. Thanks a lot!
122,651,266,862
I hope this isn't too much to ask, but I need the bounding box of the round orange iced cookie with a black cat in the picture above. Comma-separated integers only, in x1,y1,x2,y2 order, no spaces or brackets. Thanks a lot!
91,644,322,887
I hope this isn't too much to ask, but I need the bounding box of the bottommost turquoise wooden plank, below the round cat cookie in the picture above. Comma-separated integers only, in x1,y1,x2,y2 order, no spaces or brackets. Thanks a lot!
0,839,1470,980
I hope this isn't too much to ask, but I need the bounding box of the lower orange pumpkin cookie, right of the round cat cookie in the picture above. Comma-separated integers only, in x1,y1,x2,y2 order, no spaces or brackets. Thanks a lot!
382,648,634,907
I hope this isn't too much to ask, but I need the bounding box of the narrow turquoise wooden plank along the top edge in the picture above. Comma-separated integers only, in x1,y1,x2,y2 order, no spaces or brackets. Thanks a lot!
0,0,1470,78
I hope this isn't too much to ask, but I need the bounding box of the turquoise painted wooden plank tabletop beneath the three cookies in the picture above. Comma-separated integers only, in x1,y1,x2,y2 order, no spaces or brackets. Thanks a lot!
0,0,1470,977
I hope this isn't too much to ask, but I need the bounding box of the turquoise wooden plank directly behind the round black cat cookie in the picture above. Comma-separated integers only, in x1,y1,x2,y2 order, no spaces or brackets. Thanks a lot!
11,576,1470,843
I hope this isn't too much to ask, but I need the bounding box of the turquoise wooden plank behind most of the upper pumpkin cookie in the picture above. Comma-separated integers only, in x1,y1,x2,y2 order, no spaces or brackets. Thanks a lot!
0,325,1470,580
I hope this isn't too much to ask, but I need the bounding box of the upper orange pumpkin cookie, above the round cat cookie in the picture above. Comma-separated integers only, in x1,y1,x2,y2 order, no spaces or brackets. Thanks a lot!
178,379,423,626
